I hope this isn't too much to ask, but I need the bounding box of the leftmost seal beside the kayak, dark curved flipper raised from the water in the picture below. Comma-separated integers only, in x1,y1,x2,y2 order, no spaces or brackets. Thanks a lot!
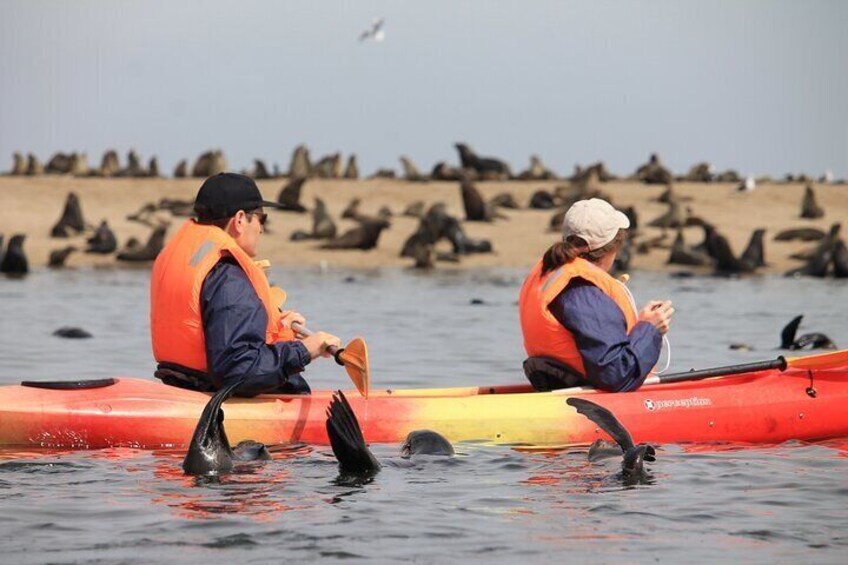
183,380,271,476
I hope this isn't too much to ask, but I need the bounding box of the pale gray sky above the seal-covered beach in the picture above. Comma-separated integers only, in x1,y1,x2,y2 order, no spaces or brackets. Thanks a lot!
0,0,848,177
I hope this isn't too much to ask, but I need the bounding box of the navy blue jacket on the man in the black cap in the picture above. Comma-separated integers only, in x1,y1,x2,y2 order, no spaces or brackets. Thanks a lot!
200,260,311,396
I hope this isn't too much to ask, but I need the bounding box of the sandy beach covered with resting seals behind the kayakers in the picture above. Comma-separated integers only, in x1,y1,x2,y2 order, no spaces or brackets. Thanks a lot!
0,176,848,274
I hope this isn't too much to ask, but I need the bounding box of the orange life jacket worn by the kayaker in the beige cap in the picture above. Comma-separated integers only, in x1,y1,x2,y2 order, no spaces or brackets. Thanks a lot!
518,257,637,377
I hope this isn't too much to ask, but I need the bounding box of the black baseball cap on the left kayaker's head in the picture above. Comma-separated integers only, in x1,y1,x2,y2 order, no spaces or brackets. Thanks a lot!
194,173,281,220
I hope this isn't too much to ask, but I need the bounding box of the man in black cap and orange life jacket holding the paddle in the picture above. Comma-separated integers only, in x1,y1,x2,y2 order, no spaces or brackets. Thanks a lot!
150,173,340,396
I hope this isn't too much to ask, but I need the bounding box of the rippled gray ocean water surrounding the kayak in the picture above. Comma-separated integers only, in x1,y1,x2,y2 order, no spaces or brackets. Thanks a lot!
0,268,848,563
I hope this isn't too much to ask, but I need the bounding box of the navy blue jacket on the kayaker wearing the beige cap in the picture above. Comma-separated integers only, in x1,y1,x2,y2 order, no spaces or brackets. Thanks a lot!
548,278,662,392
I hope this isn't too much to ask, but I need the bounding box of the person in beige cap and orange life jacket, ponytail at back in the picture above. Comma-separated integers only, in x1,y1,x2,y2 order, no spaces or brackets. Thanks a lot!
519,198,674,392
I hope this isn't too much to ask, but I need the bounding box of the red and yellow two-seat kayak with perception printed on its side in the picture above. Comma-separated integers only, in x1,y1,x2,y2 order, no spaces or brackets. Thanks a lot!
0,356,848,449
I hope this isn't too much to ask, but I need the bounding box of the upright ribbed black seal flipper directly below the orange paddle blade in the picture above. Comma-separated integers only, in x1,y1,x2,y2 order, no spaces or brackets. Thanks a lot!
327,391,380,474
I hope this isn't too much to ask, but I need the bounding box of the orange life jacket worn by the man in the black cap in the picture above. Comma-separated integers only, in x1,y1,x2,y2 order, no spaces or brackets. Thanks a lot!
150,220,294,373
